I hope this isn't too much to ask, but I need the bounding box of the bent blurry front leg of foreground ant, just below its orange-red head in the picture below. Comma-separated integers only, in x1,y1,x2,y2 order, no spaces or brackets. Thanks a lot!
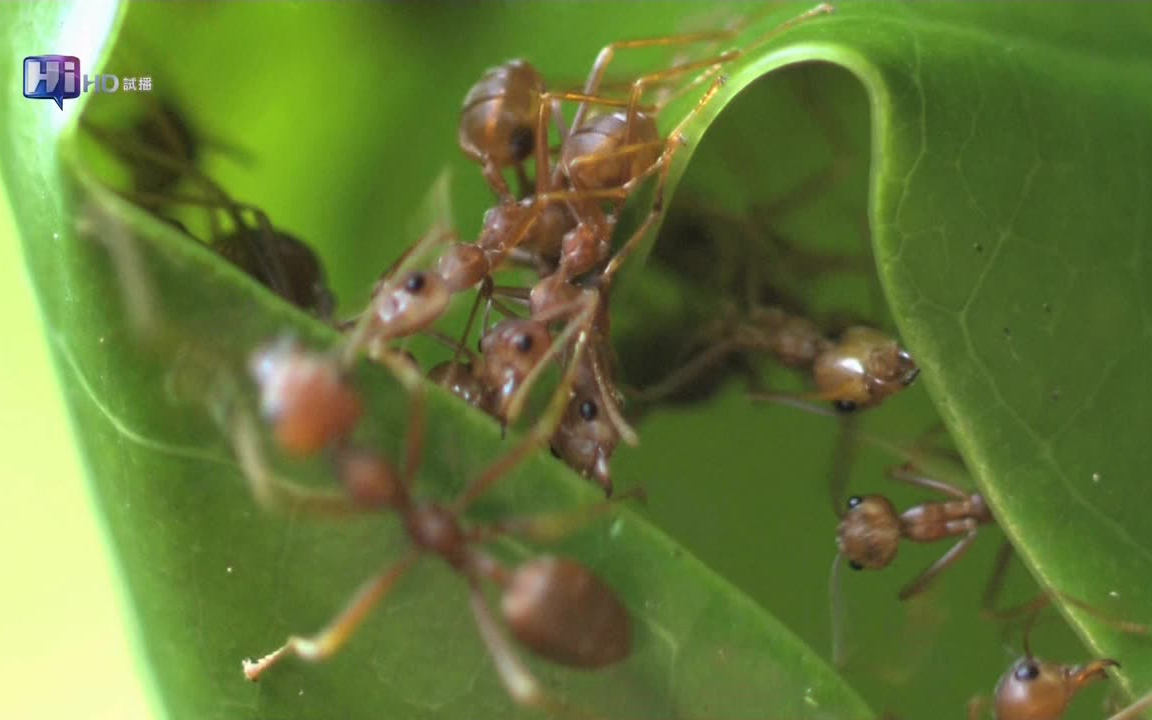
230,410,367,517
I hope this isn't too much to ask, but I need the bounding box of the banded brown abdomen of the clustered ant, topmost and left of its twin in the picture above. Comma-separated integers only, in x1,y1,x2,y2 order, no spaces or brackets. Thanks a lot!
458,60,544,168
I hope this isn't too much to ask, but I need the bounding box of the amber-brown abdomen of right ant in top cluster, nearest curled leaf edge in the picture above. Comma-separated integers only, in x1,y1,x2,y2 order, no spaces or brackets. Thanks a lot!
560,112,664,190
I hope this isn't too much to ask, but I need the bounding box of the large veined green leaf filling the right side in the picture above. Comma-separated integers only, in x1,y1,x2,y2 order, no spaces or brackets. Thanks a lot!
843,5,1152,691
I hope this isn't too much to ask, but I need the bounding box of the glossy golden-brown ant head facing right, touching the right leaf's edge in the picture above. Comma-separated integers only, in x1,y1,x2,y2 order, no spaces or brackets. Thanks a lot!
812,326,919,411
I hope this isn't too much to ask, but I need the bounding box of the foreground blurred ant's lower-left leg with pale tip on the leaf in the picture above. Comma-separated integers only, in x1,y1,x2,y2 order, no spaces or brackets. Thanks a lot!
241,550,419,682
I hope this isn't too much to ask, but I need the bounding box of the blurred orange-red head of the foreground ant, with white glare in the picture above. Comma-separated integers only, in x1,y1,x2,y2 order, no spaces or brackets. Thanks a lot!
251,340,363,455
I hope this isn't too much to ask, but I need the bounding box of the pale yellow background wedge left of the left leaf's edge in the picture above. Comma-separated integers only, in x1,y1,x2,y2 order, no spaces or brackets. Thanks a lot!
0,184,151,720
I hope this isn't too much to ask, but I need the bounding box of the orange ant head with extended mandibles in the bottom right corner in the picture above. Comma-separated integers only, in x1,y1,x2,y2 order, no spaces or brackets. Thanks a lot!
995,654,1120,720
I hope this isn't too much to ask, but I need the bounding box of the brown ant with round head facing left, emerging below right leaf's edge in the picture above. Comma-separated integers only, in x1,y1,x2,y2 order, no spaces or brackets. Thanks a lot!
836,465,995,600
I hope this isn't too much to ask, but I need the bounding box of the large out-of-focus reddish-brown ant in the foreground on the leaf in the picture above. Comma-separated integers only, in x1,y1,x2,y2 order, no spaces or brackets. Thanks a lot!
228,334,631,712
